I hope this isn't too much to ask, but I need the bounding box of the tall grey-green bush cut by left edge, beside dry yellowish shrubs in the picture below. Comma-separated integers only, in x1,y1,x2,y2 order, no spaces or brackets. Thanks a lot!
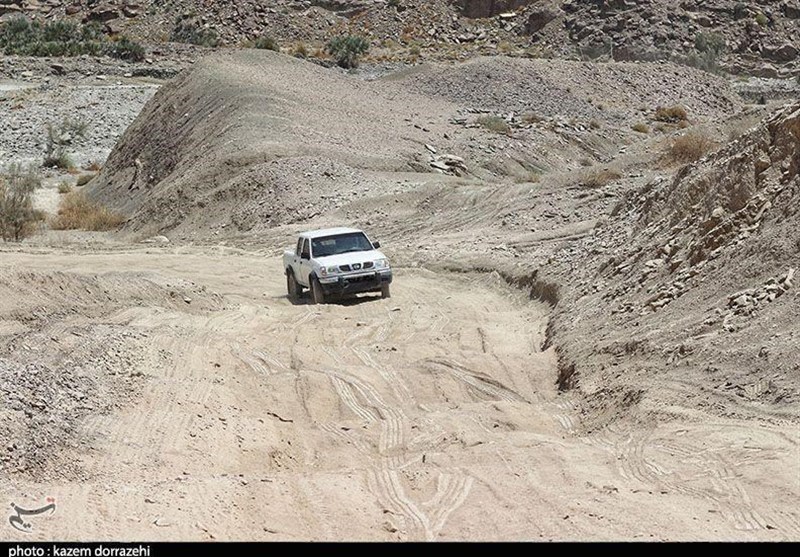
0,165,44,242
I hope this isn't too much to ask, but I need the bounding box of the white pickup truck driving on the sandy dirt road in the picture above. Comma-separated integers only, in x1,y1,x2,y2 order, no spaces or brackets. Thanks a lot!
283,228,392,304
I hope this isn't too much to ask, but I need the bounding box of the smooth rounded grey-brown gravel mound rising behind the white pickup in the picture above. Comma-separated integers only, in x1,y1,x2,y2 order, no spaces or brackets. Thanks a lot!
84,50,741,238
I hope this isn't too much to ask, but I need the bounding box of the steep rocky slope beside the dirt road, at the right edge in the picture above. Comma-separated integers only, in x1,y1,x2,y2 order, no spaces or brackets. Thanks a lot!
548,103,800,427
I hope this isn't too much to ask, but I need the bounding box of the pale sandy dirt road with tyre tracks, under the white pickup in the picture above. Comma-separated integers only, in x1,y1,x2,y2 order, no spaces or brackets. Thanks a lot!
0,248,800,540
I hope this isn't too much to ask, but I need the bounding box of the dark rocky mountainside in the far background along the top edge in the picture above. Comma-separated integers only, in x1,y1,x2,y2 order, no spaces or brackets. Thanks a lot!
0,0,800,77
